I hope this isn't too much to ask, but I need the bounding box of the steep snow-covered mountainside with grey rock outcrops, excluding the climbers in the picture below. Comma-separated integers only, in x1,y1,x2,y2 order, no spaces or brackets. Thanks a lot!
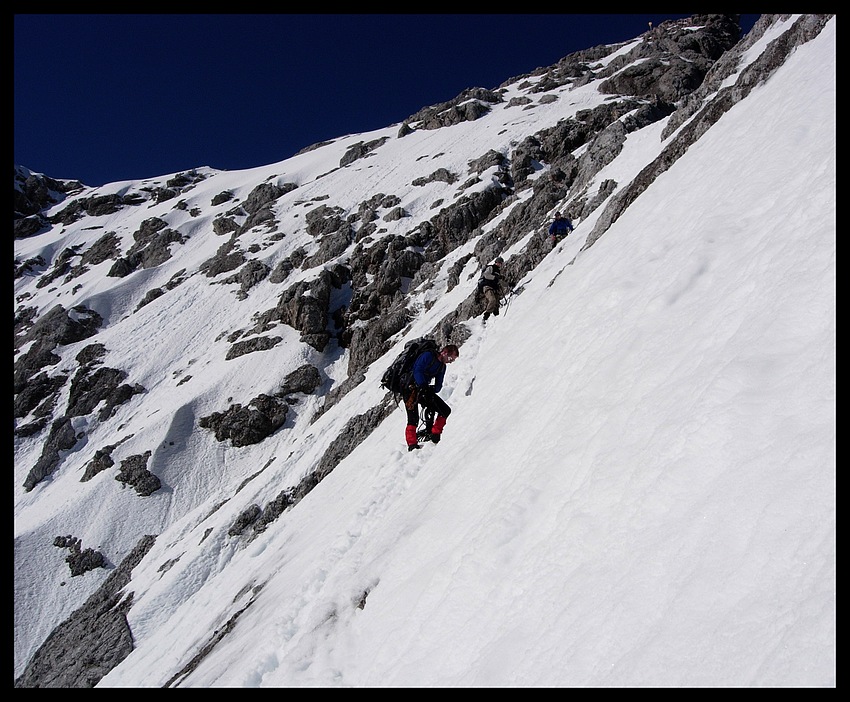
14,15,836,687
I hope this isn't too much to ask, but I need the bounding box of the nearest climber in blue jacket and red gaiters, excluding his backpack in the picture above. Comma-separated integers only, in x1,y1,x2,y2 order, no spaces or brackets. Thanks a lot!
404,344,458,451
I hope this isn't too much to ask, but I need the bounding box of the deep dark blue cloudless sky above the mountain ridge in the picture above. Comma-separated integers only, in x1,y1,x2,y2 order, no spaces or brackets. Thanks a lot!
14,14,758,190
